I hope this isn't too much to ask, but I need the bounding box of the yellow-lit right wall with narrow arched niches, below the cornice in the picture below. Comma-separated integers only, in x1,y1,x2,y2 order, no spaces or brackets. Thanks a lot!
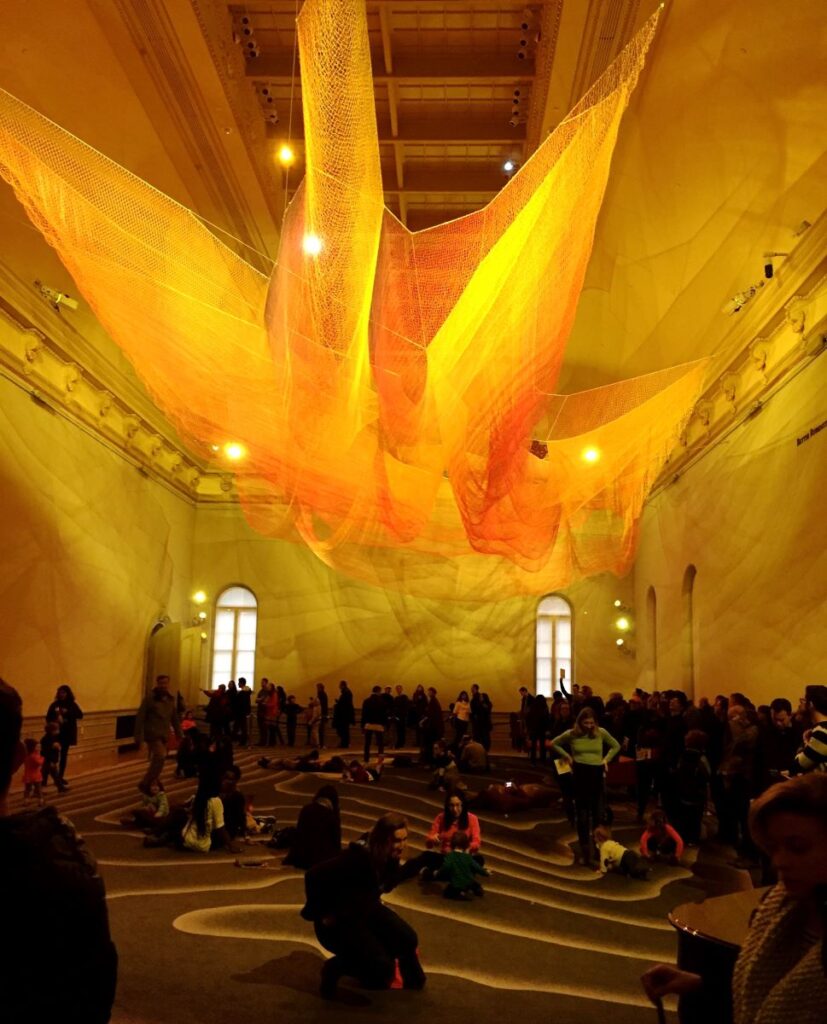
635,356,827,703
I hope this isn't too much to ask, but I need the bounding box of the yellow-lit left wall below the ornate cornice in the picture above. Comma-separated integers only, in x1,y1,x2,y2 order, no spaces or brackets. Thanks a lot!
0,372,193,715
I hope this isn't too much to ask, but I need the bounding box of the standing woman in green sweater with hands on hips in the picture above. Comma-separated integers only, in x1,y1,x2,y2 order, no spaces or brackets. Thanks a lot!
554,708,620,866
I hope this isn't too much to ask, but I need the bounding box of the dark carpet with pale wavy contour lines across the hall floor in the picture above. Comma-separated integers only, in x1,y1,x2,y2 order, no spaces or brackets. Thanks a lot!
20,751,741,1024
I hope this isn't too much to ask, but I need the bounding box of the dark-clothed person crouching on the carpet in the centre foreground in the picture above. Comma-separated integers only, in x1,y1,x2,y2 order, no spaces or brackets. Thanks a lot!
301,812,425,998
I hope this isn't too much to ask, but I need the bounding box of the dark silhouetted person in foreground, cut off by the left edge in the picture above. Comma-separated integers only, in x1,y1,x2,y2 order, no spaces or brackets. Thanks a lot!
0,680,118,1024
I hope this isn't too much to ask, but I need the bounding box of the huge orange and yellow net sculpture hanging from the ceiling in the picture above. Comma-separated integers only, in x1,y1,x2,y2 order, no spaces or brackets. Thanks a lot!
0,0,704,600
